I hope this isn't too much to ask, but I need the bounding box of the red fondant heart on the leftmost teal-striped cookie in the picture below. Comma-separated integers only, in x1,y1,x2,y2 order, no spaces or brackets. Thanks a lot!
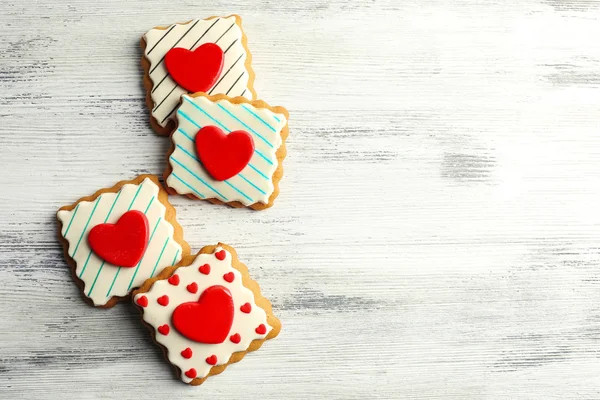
88,210,148,268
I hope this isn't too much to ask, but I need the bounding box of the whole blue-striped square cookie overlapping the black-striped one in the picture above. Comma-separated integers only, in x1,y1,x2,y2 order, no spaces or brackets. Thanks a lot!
165,93,289,210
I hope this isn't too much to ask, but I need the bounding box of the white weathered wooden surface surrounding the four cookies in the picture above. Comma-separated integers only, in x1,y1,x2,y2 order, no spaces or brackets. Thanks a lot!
0,0,600,400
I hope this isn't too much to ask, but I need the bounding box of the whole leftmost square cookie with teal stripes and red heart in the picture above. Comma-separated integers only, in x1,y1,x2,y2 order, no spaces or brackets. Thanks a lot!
57,175,190,308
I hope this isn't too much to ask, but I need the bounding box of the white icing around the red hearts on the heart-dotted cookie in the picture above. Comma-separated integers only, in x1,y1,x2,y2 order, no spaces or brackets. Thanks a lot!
135,247,272,383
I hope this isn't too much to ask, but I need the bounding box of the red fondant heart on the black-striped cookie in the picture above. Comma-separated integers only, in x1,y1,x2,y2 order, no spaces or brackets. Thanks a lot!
165,43,223,93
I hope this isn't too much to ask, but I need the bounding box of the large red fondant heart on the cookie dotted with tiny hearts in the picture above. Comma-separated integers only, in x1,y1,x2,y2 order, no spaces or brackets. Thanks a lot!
172,285,233,344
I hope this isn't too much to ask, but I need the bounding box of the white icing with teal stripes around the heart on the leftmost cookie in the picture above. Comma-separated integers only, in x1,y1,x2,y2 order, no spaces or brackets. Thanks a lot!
58,178,181,306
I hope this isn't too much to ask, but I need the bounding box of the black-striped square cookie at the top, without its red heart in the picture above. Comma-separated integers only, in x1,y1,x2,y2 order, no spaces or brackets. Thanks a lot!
141,15,256,135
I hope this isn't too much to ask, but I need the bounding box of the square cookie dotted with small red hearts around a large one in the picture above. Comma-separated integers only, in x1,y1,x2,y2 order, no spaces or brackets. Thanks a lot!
133,243,281,385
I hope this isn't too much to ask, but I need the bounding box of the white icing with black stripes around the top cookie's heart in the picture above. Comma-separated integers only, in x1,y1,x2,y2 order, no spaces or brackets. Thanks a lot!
144,16,252,127
